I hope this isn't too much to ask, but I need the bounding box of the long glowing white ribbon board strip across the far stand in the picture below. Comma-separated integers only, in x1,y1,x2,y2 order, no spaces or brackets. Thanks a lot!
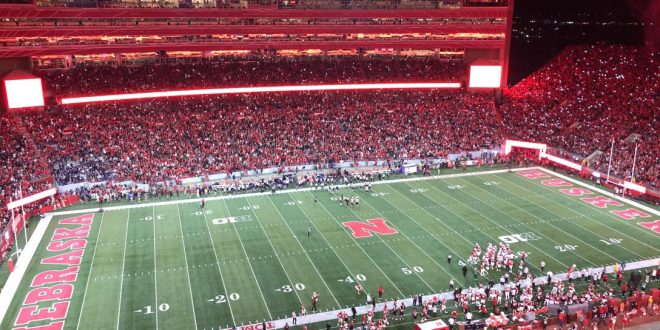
60,82,461,104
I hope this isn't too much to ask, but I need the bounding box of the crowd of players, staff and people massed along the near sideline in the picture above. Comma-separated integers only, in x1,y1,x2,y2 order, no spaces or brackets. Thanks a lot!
312,248,660,330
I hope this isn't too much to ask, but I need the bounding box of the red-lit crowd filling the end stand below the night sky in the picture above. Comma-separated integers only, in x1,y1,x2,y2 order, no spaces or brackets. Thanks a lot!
500,45,660,187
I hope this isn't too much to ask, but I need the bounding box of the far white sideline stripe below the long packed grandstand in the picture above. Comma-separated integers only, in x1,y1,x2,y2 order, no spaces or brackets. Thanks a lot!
47,167,524,216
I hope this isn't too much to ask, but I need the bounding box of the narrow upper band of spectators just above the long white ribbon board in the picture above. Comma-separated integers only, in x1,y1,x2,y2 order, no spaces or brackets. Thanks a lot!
41,56,465,96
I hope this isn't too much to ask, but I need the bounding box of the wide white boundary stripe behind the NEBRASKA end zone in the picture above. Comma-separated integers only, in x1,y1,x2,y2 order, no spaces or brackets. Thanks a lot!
0,215,53,323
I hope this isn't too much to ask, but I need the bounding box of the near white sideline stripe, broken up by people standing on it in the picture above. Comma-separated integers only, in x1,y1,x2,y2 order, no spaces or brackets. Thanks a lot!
244,258,660,329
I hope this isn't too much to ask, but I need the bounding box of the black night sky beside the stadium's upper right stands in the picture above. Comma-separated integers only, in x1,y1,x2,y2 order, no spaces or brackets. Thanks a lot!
509,0,660,85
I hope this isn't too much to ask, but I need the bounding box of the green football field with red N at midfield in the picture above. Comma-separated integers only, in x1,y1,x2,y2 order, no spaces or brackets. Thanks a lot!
0,170,660,329
